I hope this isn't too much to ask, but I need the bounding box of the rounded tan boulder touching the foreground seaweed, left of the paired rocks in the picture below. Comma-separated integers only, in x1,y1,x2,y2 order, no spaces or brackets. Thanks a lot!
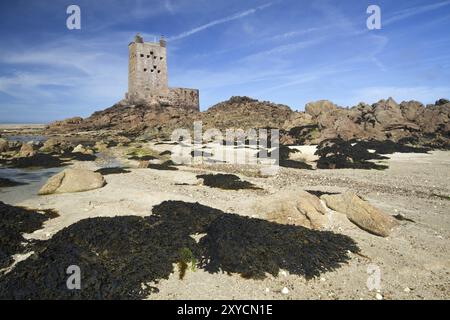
254,191,328,230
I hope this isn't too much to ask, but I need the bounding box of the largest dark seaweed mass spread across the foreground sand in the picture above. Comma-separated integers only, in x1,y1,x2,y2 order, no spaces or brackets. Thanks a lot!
0,201,359,299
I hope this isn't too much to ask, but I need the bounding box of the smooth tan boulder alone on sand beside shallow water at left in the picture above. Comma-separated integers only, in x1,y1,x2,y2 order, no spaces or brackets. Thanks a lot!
39,169,105,195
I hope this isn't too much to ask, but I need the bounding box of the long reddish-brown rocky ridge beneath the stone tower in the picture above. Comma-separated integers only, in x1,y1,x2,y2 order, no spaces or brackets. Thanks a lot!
46,97,450,148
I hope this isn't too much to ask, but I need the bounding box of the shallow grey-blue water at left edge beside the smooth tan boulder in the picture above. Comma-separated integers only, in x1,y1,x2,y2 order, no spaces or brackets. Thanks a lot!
0,167,64,205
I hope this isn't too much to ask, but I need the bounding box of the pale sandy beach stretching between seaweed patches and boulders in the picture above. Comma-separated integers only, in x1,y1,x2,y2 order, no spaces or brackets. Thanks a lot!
0,143,450,299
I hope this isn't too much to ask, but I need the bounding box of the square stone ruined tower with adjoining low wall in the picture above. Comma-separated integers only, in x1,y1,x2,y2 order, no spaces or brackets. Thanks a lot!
126,34,199,110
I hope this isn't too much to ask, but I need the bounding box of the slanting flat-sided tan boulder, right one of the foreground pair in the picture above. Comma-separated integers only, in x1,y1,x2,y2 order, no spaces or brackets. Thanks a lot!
321,192,397,237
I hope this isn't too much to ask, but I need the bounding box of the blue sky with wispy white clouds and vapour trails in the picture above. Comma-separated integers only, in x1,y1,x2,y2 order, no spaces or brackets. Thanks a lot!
0,0,450,123
